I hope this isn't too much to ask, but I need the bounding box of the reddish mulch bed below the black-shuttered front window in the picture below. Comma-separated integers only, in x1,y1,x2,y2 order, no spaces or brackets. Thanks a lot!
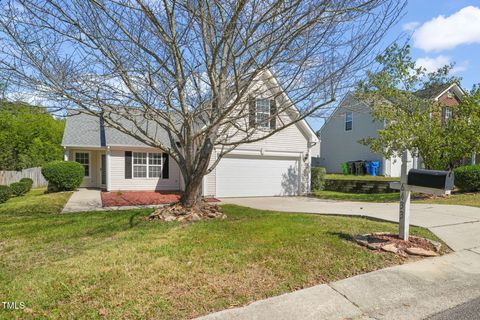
102,191,181,207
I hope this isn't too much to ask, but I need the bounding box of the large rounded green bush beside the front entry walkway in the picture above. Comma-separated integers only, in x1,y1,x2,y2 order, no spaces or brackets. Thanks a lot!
42,161,85,192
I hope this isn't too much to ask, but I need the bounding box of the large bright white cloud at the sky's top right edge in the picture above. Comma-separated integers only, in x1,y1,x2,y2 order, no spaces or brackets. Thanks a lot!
413,6,480,51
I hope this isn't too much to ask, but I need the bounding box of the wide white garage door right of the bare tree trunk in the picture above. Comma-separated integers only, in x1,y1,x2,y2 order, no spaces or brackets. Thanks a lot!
216,156,298,197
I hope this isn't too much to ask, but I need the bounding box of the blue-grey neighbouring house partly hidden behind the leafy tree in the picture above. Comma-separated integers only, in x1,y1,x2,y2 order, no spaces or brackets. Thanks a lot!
319,83,464,177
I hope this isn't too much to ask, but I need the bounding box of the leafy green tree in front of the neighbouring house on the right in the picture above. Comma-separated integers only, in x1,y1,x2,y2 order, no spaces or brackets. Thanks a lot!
357,44,480,169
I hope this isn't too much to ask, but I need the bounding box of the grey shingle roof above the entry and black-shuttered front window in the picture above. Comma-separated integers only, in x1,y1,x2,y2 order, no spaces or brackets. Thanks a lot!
62,113,177,148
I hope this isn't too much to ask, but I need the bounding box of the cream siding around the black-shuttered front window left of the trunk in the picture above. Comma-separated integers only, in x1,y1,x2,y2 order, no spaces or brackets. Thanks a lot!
110,148,181,191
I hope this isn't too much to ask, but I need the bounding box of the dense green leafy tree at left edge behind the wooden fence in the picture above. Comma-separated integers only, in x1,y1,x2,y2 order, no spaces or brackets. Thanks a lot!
0,101,65,170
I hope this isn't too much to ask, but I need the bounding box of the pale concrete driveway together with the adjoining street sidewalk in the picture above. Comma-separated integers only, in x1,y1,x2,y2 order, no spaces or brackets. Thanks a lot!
198,197,480,320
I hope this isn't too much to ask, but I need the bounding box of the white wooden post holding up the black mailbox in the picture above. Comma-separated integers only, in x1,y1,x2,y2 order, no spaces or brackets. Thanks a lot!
399,150,412,240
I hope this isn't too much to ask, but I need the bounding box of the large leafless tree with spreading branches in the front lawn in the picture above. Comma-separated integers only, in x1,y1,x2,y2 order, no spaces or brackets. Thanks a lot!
0,0,405,207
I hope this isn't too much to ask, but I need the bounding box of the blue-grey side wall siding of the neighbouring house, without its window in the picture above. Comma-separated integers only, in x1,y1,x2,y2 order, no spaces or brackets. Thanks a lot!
320,94,391,174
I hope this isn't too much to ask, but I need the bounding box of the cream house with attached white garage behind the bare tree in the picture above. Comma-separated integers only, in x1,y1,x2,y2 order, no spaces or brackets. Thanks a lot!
62,73,318,197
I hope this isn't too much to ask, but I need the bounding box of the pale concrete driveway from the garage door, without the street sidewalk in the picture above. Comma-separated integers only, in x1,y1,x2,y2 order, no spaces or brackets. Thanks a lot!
220,197,480,251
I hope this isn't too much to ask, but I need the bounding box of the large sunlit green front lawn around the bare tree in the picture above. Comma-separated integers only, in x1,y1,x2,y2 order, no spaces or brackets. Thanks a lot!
0,190,436,319
